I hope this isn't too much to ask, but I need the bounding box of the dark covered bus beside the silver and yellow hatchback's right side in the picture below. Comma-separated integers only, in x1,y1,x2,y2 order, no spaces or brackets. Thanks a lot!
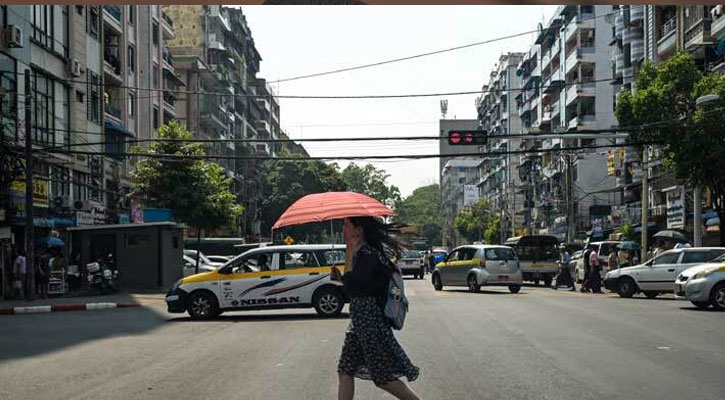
505,235,559,286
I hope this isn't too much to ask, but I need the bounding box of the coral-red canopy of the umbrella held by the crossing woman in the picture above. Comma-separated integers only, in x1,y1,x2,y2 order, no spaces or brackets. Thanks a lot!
272,192,394,229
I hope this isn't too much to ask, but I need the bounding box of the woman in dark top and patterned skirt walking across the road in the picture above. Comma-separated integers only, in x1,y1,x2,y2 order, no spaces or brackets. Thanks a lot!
330,217,420,400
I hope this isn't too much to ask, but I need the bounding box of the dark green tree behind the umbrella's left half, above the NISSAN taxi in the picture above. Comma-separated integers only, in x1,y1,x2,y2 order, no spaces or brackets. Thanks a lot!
261,152,347,240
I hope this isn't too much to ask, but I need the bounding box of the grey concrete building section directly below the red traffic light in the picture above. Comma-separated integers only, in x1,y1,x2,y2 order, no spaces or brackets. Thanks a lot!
441,158,481,248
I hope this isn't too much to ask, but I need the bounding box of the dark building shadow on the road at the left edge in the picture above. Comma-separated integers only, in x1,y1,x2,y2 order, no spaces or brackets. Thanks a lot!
0,307,164,364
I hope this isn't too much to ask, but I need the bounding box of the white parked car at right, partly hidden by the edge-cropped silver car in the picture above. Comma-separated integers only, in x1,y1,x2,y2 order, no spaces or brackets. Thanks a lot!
604,247,725,298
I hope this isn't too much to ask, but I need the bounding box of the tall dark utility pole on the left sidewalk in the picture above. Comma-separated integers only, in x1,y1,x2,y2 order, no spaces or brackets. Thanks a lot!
25,69,35,300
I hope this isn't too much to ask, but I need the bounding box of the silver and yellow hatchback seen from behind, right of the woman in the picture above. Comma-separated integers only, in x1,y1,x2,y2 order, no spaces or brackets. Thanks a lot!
431,245,523,293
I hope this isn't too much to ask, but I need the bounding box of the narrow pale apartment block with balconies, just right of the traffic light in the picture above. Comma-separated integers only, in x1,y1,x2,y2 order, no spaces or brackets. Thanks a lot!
476,53,525,236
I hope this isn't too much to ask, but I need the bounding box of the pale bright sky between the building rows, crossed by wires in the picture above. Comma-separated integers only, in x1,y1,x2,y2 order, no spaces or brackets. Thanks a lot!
242,5,556,197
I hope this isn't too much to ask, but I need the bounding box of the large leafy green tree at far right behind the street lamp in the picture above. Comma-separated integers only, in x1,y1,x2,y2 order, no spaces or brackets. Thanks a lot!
615,53,725,243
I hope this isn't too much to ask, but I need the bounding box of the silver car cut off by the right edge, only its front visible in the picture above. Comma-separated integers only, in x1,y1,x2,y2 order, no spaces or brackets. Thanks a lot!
675,255,725,311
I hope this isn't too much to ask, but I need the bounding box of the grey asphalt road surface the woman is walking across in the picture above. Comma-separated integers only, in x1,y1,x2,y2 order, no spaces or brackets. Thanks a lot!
0,280,725,400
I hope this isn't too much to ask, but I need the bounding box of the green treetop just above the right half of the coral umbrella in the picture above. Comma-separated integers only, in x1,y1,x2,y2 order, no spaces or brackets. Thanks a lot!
342,163,400,204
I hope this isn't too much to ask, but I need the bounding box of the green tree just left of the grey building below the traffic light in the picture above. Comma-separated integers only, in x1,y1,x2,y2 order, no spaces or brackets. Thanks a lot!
395,184,443,245
